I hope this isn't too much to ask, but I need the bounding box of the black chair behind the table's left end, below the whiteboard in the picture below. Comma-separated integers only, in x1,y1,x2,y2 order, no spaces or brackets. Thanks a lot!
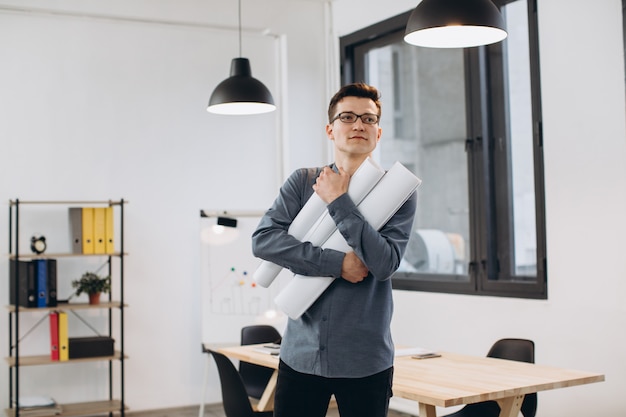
239,324,281,400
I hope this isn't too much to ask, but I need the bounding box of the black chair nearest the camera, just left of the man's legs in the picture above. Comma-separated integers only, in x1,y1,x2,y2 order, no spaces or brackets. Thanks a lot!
209,350,273,417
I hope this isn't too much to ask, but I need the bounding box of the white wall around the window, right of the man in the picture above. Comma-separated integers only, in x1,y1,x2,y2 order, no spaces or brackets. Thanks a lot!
334,0,626,417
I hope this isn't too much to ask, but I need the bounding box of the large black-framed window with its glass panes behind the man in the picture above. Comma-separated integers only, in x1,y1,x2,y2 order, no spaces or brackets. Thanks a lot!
340,0,547,298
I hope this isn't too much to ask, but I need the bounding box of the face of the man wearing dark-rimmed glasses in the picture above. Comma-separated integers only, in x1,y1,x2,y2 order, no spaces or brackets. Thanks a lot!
326,97,382,156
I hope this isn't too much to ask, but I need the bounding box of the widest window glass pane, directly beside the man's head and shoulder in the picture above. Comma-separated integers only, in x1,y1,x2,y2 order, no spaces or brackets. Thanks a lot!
365,40,469,275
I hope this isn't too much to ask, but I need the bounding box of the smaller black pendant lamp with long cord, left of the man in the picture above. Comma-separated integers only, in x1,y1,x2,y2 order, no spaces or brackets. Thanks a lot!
207,0,276,115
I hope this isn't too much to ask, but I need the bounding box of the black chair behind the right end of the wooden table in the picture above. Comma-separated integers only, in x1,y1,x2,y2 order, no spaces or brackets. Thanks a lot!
446,339,537,417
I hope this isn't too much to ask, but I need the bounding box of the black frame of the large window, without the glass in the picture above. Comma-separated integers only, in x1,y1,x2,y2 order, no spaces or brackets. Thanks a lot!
339,0,548,299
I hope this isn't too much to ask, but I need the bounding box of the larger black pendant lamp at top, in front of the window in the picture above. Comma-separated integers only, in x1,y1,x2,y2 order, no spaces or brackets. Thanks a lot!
404,0,507,48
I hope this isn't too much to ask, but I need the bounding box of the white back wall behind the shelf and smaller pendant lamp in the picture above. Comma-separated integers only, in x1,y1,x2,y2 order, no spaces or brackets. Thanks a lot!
0,0,327,410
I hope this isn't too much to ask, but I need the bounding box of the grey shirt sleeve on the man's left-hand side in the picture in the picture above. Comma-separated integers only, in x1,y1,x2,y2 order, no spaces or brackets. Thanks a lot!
252,169,344,278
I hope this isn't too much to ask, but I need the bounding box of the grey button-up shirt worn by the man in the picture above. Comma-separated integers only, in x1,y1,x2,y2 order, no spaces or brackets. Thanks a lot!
252,164,417,378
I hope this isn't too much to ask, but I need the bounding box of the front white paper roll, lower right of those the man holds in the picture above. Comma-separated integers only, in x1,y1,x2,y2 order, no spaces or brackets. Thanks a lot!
274,162,422,320
